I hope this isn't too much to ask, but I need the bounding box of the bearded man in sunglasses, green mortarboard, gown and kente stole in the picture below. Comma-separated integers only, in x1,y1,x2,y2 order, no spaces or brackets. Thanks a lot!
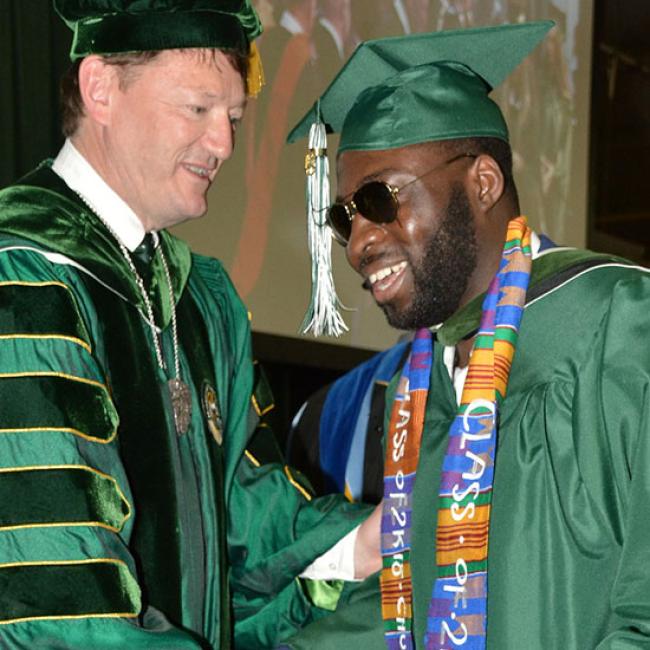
286,23,650,650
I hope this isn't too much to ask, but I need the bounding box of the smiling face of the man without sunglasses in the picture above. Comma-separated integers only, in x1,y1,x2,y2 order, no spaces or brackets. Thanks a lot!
85,50,246,230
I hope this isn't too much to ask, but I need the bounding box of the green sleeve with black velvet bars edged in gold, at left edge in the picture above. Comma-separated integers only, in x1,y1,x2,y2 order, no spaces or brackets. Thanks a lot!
0,248,198,649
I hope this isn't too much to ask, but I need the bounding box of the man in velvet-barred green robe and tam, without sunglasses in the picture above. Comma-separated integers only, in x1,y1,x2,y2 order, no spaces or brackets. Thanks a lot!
0,0,380,650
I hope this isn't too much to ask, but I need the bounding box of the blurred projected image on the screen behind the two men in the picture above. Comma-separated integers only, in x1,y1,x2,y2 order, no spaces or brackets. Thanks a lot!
185,0,591,340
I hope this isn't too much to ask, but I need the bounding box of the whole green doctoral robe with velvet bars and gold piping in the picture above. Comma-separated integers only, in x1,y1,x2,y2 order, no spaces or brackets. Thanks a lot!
0,165,363,650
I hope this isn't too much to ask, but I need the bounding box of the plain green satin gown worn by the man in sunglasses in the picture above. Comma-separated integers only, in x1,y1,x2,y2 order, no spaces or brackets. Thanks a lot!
288,250,650,650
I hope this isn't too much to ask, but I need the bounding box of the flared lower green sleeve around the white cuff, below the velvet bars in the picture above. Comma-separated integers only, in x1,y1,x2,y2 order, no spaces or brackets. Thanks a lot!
229,455,369,649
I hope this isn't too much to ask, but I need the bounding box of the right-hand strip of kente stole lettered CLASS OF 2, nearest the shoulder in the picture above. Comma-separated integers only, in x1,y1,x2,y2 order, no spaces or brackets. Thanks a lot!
425,217,531,650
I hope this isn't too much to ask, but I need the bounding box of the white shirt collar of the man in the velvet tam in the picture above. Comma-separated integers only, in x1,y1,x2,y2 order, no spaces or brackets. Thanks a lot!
52,140,146,252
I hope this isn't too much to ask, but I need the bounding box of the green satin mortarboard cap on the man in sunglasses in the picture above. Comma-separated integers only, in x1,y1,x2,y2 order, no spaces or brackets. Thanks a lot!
288,21,554,152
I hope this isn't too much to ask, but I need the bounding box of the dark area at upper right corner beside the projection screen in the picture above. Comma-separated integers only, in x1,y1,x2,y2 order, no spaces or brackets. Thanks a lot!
587,0,650,265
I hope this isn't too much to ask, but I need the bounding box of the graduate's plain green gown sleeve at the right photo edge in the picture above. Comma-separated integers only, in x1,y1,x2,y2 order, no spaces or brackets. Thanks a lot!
581,278,650,650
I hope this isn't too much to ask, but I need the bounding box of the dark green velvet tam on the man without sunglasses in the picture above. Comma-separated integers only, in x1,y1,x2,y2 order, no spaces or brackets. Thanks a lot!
54,0,262,61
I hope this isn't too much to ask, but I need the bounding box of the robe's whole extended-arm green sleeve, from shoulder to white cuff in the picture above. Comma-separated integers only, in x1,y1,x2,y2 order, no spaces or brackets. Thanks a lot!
193,256,369,650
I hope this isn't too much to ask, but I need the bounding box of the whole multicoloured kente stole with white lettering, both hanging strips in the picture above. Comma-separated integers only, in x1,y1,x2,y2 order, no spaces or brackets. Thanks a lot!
381,217,531,650
